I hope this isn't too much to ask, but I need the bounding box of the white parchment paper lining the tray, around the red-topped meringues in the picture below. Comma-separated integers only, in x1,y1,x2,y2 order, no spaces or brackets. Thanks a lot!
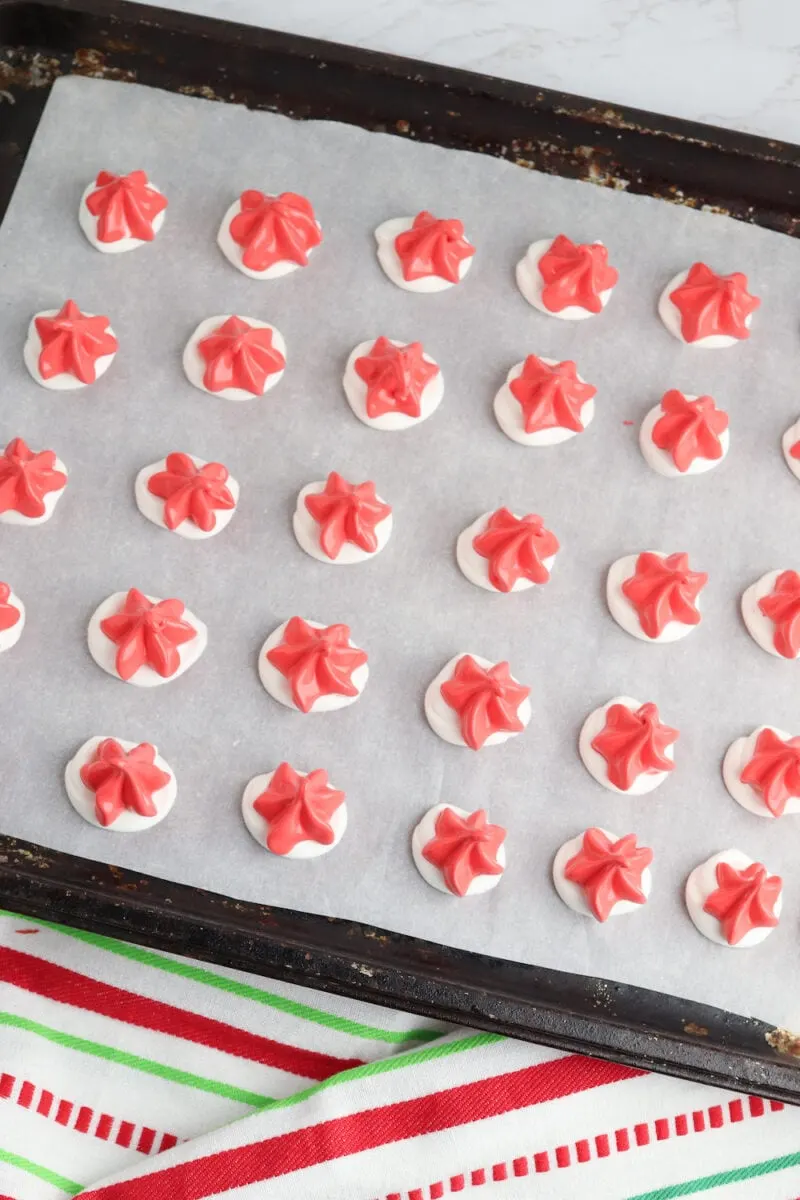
0,77,800,1027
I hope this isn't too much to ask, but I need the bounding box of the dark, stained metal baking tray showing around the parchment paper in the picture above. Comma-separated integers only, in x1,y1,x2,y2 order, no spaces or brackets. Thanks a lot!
0,0,800,1103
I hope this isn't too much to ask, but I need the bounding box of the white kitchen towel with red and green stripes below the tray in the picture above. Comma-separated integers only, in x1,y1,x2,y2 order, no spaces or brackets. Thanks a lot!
0,913,800,1200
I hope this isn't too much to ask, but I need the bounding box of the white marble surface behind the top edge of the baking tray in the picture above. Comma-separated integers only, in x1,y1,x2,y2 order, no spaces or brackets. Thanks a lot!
163,0,800,142
